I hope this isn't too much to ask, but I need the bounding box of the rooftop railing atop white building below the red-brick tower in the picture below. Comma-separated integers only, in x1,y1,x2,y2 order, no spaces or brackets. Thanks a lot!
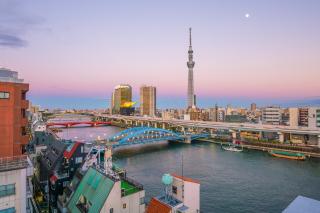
0,155,29,172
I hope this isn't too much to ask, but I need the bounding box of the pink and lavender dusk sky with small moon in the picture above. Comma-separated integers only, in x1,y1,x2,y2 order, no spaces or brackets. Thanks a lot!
0,0,320,108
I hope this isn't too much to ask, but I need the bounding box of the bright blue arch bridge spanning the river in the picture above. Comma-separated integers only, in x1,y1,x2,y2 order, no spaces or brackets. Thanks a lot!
108,127,210,148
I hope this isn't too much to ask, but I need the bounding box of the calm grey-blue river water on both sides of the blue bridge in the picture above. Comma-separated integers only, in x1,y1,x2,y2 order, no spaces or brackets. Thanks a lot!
58,126,320,213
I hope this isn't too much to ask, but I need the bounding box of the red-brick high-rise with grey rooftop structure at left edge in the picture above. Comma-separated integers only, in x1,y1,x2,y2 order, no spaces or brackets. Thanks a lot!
0,68,29,157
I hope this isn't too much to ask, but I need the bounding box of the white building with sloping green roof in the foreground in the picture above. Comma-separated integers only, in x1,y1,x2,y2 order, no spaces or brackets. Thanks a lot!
65,167,145,213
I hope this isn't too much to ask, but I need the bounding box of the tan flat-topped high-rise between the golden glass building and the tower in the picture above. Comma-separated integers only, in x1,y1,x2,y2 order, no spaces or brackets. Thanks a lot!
140,86,157,116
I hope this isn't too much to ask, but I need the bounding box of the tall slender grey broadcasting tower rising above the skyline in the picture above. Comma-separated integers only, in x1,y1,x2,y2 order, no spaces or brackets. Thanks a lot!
187,28,196,108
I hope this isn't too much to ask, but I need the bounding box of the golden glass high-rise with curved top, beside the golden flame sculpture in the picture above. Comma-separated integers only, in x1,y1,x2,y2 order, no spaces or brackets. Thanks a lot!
111,84,132,114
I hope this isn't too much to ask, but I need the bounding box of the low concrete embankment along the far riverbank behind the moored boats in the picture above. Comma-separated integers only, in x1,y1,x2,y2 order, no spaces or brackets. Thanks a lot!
198,139,320,158
